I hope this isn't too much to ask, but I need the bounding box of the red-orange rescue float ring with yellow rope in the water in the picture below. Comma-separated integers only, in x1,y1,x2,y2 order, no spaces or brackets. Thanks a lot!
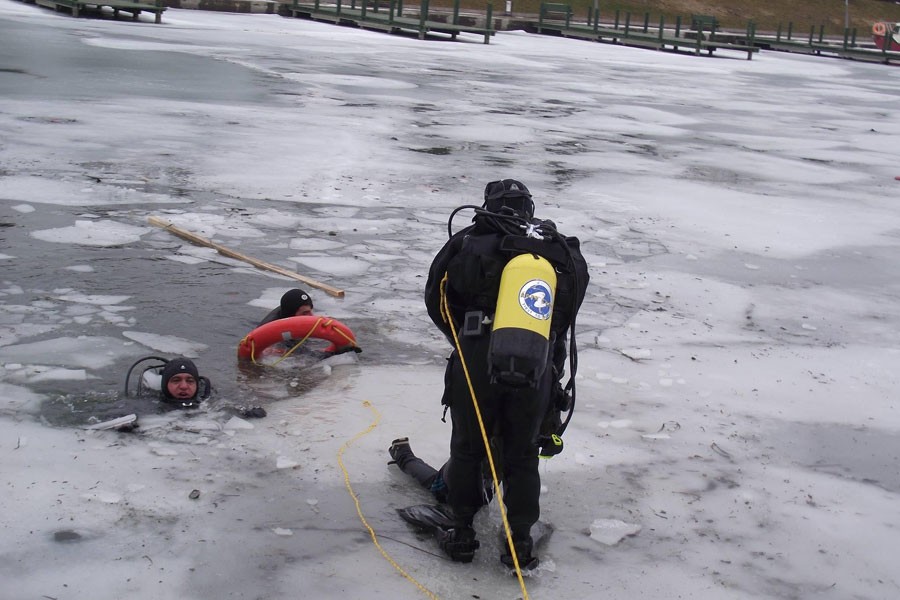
238,315,359,360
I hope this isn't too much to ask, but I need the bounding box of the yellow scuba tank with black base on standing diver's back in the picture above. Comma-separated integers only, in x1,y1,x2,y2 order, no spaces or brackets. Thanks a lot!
488,254,556,387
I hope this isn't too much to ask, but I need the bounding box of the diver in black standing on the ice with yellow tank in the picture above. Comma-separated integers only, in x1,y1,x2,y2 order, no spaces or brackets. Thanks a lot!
391,179,588,569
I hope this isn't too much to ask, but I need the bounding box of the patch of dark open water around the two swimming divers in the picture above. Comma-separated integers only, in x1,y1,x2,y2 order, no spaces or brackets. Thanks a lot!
0,202,406,425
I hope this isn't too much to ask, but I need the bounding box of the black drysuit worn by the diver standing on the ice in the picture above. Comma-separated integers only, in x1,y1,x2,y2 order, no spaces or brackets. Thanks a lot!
425,213,588,538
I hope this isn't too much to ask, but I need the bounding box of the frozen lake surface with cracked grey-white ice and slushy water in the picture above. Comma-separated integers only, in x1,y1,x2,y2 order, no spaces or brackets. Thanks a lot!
0,0,900,600
